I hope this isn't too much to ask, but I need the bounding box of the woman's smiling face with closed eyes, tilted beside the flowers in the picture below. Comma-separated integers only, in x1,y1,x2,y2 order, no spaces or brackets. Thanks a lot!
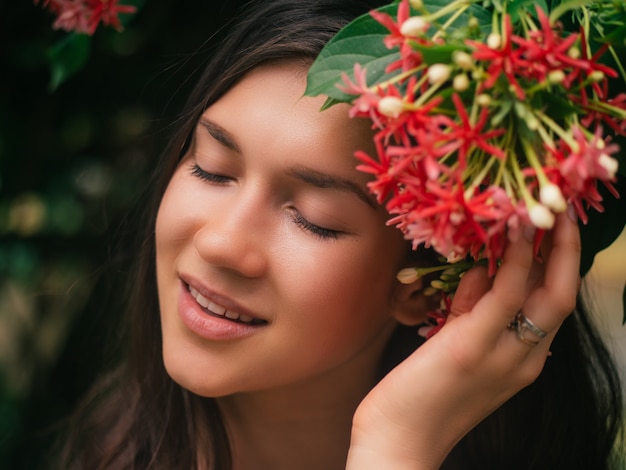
156,60,406,396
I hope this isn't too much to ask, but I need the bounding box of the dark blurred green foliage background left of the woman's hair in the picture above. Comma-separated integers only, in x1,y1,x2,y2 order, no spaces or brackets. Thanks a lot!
0,0,242,470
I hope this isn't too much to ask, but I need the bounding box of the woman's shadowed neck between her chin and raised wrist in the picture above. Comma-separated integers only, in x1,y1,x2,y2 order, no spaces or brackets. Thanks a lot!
218,330,390,470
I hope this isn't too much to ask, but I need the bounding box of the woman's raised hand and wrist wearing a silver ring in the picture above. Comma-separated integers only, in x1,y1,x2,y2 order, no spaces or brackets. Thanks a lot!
346,210,580,470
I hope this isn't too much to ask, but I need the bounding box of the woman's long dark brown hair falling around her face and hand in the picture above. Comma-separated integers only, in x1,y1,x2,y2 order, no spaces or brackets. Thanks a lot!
59,0,621,470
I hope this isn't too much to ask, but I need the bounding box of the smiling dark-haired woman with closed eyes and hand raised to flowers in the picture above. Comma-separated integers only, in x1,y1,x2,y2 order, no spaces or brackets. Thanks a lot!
56,0,621,469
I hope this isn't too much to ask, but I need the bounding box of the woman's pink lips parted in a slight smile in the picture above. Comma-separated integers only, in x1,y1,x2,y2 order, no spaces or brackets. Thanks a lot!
178,281,267,341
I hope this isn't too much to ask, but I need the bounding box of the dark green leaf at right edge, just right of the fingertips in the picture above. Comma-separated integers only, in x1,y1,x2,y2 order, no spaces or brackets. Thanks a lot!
579,174,626,276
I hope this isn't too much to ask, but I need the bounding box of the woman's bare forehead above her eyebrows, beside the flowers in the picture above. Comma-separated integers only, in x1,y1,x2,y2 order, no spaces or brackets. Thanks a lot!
203,62,373,182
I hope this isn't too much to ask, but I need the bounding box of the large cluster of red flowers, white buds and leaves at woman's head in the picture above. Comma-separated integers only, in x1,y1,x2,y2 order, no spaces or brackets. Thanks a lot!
307,0,626,334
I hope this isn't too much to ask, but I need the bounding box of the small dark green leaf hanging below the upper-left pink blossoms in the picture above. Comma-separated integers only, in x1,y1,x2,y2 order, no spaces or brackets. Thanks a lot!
48,33,91,92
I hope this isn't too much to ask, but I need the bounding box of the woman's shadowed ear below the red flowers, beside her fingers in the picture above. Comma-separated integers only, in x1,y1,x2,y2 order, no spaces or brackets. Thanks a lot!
392,278,439,326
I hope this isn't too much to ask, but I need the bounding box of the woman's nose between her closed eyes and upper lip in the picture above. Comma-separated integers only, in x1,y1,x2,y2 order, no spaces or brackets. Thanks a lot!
194,185,271,278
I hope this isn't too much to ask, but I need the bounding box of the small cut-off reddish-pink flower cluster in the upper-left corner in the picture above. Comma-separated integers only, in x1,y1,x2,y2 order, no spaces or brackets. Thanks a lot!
34,0,136,36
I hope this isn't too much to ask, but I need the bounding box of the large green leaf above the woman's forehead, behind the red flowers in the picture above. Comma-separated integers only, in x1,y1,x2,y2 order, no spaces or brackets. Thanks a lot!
305,0,491,103
